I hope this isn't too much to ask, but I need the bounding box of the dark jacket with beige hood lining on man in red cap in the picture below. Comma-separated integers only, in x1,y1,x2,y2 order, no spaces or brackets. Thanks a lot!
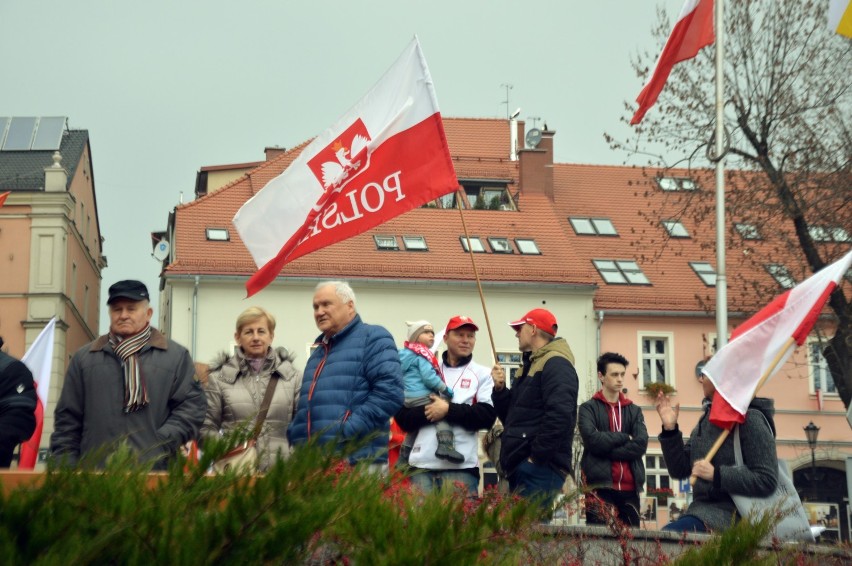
492,338,579,477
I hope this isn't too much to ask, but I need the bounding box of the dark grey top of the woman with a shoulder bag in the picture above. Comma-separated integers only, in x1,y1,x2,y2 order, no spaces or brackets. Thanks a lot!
660,398,778,531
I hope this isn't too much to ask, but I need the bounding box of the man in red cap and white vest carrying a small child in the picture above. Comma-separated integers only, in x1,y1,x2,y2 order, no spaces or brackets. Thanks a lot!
395,316,497,496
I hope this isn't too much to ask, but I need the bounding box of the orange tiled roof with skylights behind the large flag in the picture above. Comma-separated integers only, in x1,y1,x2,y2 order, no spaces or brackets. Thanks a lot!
166,118,848,312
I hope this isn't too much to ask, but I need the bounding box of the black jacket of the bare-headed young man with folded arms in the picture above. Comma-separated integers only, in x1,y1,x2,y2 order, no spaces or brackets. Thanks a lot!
577,398,648,493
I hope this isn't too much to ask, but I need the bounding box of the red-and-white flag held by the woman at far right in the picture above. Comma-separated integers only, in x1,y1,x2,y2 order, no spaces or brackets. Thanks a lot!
702,251,852,430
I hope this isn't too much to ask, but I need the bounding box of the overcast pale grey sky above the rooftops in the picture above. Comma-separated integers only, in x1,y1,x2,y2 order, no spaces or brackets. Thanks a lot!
0,0,683,332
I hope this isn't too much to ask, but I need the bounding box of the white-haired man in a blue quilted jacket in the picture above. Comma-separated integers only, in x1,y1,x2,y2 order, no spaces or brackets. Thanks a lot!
287,281,403,471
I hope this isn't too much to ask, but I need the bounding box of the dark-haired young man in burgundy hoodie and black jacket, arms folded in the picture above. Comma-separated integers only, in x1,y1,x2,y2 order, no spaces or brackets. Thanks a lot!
577,352,648,527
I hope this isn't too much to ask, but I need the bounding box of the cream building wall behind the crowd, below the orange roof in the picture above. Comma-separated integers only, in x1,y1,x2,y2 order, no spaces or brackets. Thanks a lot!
160,276,597,399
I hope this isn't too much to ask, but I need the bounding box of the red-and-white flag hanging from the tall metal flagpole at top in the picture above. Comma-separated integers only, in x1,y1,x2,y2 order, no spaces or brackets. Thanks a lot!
630,0,715,125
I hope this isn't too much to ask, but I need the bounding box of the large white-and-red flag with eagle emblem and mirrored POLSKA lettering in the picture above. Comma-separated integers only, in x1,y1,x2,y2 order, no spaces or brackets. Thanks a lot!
233,37,458,296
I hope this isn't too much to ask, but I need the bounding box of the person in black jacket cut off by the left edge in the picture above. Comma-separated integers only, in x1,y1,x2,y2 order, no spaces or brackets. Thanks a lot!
0,338,37,468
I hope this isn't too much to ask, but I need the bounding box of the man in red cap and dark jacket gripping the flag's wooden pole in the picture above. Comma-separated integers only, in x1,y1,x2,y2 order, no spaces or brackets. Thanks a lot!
494,309,579,512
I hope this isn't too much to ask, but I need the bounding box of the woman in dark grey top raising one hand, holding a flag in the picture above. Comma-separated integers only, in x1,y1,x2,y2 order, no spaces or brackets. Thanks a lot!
655,380,778,533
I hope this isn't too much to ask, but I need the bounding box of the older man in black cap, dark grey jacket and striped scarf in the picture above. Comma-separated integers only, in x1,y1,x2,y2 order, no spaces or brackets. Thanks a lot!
50,280,207,470
